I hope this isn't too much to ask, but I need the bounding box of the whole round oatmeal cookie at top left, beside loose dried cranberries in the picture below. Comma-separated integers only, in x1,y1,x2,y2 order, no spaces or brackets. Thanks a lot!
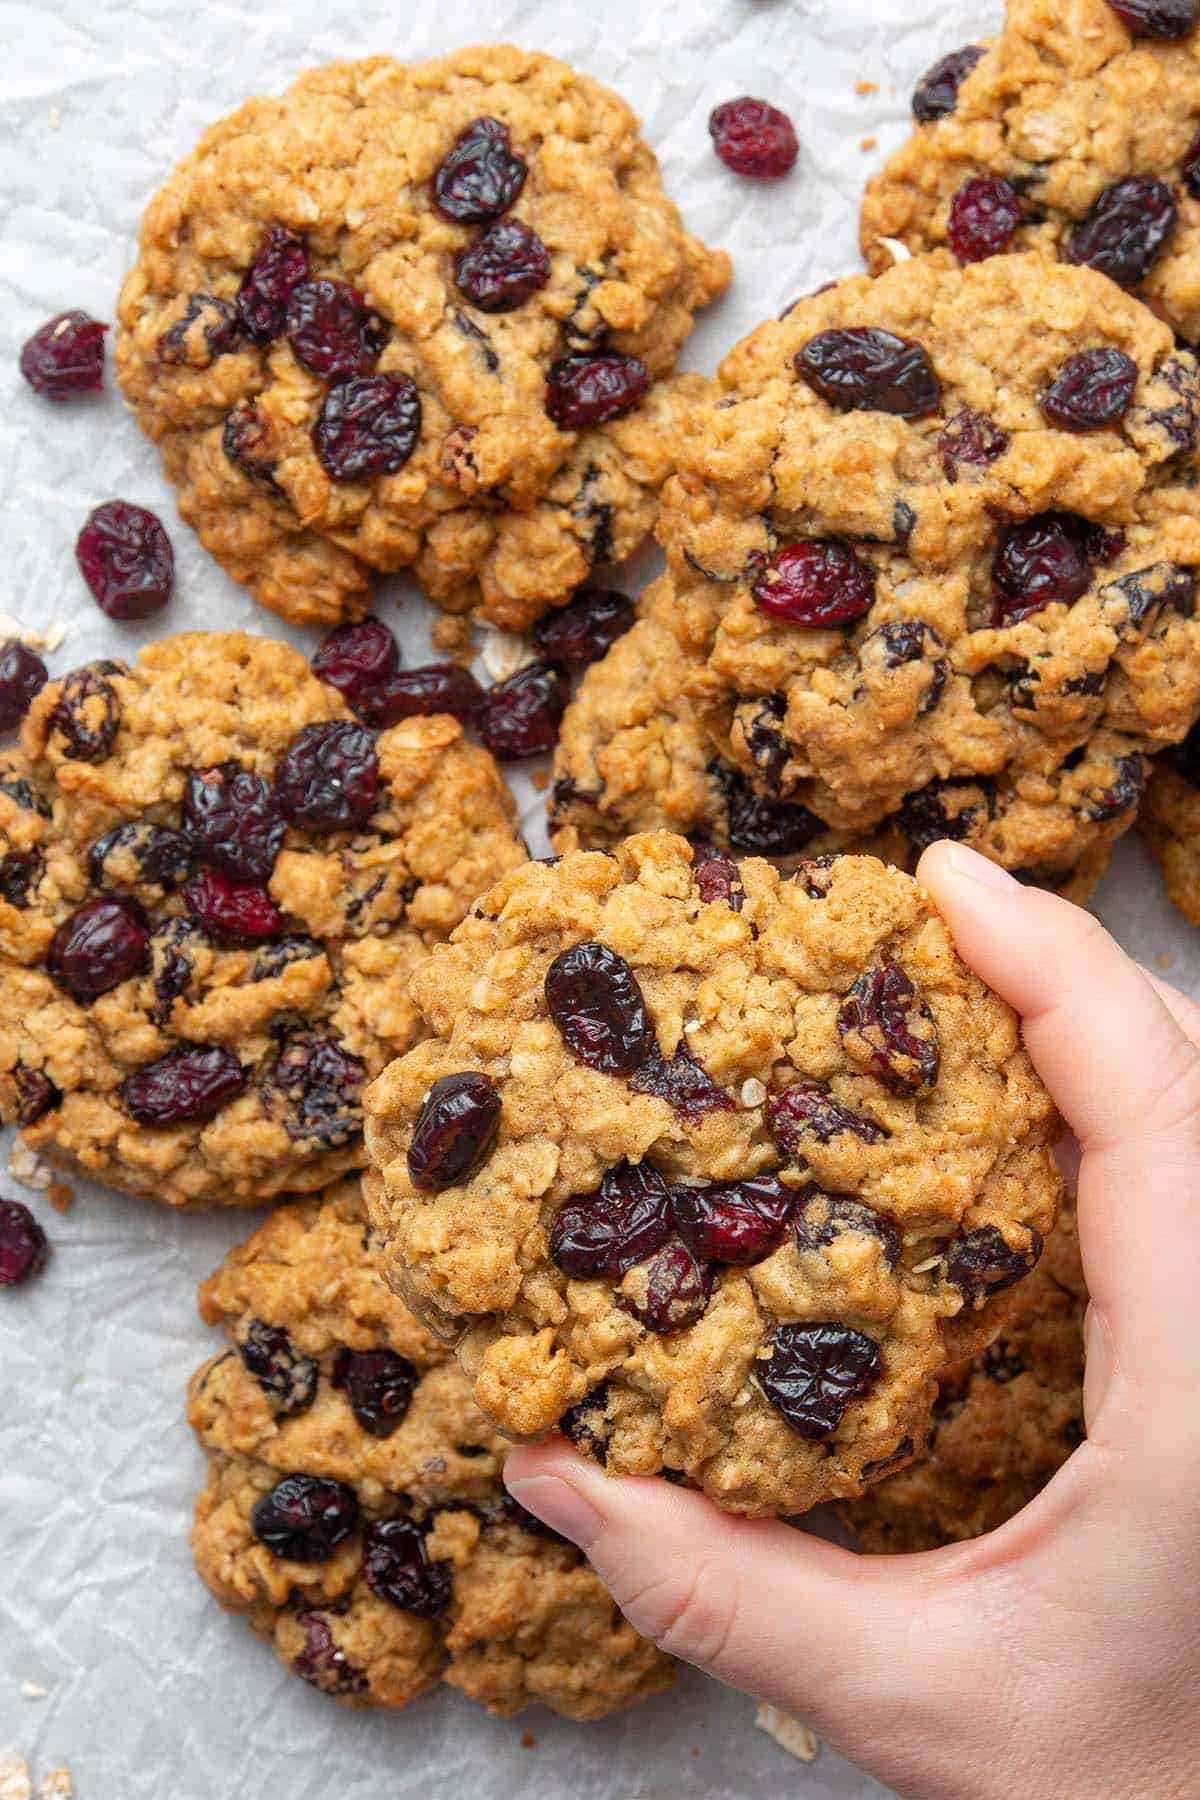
115,45,730,630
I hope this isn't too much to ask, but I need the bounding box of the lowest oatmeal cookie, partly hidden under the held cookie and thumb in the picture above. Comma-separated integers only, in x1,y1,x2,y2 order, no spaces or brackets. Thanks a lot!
189,1181,673,1719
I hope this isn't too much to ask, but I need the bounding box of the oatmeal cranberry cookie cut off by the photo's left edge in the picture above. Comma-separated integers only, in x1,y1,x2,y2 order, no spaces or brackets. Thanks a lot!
0,632,525,1206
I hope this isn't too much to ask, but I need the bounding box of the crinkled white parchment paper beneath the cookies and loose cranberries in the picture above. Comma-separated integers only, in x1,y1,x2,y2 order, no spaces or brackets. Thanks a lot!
0,0,1200,1800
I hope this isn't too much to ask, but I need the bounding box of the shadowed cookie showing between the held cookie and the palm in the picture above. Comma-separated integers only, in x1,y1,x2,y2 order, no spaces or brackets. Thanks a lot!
838,1204,1087,1555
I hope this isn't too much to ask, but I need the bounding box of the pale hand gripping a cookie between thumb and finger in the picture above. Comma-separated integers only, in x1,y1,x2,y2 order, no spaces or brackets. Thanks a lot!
506,844,1200,1800
